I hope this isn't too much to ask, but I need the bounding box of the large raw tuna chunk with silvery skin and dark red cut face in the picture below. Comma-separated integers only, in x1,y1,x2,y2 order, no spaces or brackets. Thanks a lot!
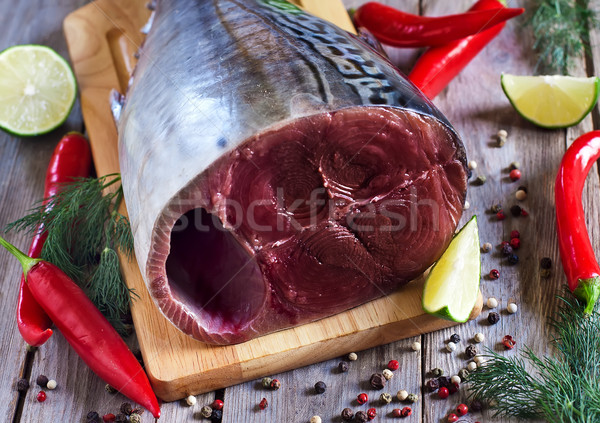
118,0,467,344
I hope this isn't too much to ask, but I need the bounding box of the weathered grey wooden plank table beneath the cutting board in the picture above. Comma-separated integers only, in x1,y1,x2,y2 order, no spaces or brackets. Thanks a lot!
0,0,600,423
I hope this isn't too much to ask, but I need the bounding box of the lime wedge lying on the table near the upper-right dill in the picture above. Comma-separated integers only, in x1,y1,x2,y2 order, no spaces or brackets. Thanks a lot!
501,74,599,128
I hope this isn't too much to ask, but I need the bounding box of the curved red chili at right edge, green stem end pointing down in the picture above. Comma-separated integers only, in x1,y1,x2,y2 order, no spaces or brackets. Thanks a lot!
554,131,600,314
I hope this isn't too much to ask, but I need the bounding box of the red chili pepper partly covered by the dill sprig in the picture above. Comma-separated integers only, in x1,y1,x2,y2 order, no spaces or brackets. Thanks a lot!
17,132,92,347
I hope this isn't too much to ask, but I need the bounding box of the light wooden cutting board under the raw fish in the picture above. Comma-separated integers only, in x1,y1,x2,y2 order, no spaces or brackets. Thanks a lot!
64,0,482,401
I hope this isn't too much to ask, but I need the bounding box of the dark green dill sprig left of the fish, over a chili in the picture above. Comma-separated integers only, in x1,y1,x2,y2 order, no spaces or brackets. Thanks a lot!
5,174,135,335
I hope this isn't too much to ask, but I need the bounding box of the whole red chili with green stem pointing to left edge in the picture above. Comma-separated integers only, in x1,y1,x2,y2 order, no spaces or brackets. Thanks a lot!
0,237,160,418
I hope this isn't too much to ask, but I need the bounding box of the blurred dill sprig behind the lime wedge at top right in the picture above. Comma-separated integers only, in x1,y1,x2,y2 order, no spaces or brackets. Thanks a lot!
529,0,598,75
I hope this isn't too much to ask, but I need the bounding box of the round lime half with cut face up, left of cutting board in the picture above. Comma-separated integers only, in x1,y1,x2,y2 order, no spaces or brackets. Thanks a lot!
0,45,77,136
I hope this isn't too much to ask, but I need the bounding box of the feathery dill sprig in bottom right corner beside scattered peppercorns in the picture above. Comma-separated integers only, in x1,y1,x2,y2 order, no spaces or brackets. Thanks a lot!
468,290,600,423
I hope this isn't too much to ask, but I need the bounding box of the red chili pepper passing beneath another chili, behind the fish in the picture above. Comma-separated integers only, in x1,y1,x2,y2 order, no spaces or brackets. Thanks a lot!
408,0,506,98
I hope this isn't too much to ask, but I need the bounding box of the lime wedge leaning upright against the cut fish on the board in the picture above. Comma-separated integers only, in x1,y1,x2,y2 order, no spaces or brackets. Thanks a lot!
423,216,481,322
